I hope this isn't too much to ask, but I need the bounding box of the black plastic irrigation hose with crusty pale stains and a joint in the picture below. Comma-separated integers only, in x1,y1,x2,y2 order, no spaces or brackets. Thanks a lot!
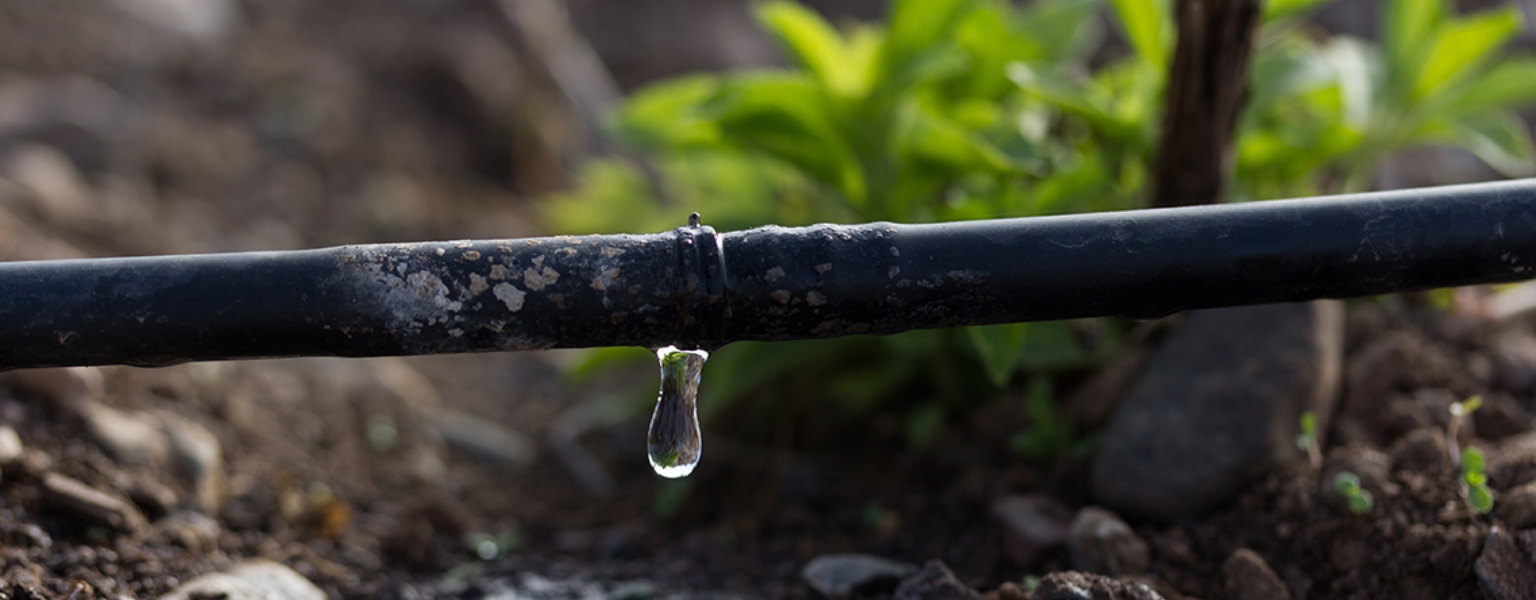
0,180,1536,368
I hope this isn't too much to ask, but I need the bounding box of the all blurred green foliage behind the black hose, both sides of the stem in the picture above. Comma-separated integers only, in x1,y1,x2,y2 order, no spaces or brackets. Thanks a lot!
545,0,1536,454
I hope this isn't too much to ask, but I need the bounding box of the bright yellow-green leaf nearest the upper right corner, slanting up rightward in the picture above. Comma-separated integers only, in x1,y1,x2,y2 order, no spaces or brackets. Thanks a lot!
1413,2,1521,98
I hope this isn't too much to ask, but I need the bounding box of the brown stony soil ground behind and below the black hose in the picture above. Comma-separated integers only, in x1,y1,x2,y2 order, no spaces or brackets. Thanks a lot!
0,0,1536,600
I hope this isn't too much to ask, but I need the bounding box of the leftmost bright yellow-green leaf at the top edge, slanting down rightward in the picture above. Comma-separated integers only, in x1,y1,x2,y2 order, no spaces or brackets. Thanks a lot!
757,2,874,98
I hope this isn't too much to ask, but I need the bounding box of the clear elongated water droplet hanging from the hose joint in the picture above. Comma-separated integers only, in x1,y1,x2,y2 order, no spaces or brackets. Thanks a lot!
645,345,710,479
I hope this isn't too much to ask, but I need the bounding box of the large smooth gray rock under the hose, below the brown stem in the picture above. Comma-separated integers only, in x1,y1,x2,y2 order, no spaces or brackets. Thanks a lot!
1091,301,1344,522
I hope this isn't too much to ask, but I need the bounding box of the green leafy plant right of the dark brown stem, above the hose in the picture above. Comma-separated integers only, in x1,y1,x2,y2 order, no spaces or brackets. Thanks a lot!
1236,0,1536,198
